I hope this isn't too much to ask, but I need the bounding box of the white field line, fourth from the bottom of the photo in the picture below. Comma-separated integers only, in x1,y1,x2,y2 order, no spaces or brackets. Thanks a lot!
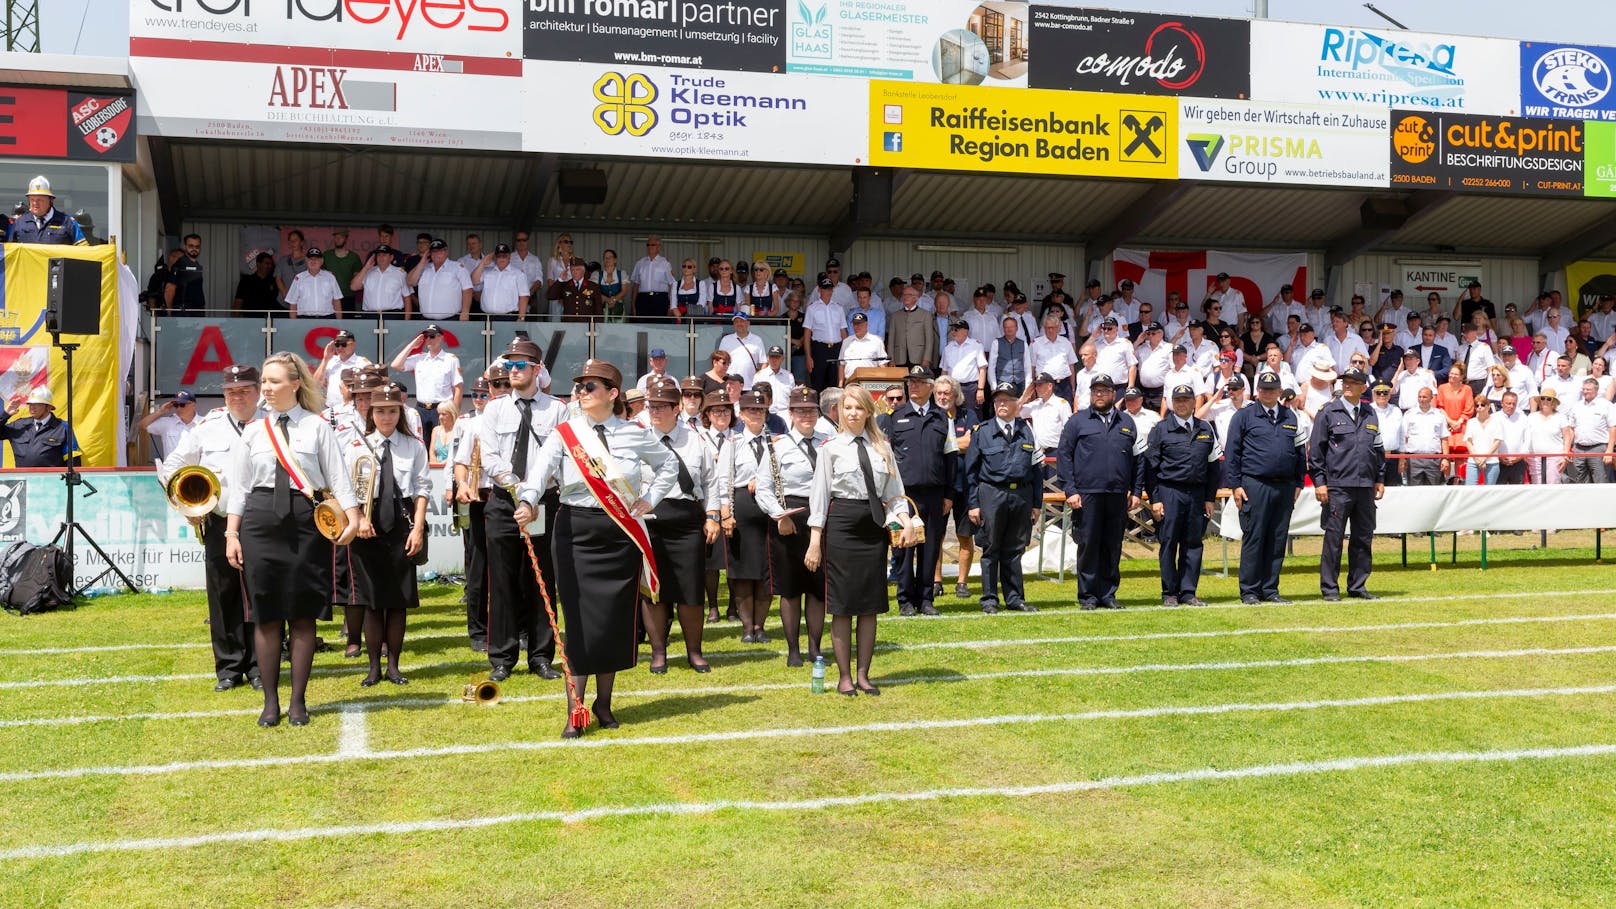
9,613,1616,691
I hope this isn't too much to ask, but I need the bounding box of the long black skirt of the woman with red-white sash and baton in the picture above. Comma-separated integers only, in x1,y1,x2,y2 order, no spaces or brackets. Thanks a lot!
549,505,640,676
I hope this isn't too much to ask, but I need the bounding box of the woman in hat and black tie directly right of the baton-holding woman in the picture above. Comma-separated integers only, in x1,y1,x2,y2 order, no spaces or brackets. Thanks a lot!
645,378,718,674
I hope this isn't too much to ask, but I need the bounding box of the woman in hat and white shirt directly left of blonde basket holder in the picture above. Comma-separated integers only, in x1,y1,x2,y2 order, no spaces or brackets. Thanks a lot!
758,385,831,666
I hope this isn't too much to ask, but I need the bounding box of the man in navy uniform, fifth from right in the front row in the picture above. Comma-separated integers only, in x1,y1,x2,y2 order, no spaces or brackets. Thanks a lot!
962,382,1044,615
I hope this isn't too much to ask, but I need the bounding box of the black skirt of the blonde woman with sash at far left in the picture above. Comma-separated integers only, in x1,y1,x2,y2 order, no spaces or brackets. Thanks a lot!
241,488,336,623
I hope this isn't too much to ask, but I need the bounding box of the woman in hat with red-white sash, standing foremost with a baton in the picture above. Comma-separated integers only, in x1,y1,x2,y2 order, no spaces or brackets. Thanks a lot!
514,359,679,739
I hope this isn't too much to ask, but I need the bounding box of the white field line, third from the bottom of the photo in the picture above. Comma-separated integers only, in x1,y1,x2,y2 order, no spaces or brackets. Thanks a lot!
9,645,1616,727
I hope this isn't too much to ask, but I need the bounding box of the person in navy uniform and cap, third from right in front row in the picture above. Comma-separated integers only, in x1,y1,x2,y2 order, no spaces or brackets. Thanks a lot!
1144,385,1223,607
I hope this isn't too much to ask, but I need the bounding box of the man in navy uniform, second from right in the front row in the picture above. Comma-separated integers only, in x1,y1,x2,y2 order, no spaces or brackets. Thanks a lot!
1223,372,1309,603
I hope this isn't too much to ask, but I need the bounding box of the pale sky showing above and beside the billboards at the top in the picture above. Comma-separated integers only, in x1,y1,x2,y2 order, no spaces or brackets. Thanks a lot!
39,0,1616,57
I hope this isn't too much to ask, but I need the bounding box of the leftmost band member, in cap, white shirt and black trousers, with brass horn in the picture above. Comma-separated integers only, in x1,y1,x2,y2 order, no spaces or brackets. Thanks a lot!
157,364,263,691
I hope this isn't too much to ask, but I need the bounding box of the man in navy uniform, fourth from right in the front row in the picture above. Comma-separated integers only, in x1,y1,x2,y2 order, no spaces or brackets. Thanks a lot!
1055,375,1144,610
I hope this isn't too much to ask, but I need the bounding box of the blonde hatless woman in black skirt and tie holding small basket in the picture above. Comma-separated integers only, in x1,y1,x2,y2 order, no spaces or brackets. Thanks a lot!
803,385,915,697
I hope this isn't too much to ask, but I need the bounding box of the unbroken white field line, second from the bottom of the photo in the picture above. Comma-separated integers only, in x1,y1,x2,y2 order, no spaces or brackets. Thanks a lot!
0,676,1616,783
